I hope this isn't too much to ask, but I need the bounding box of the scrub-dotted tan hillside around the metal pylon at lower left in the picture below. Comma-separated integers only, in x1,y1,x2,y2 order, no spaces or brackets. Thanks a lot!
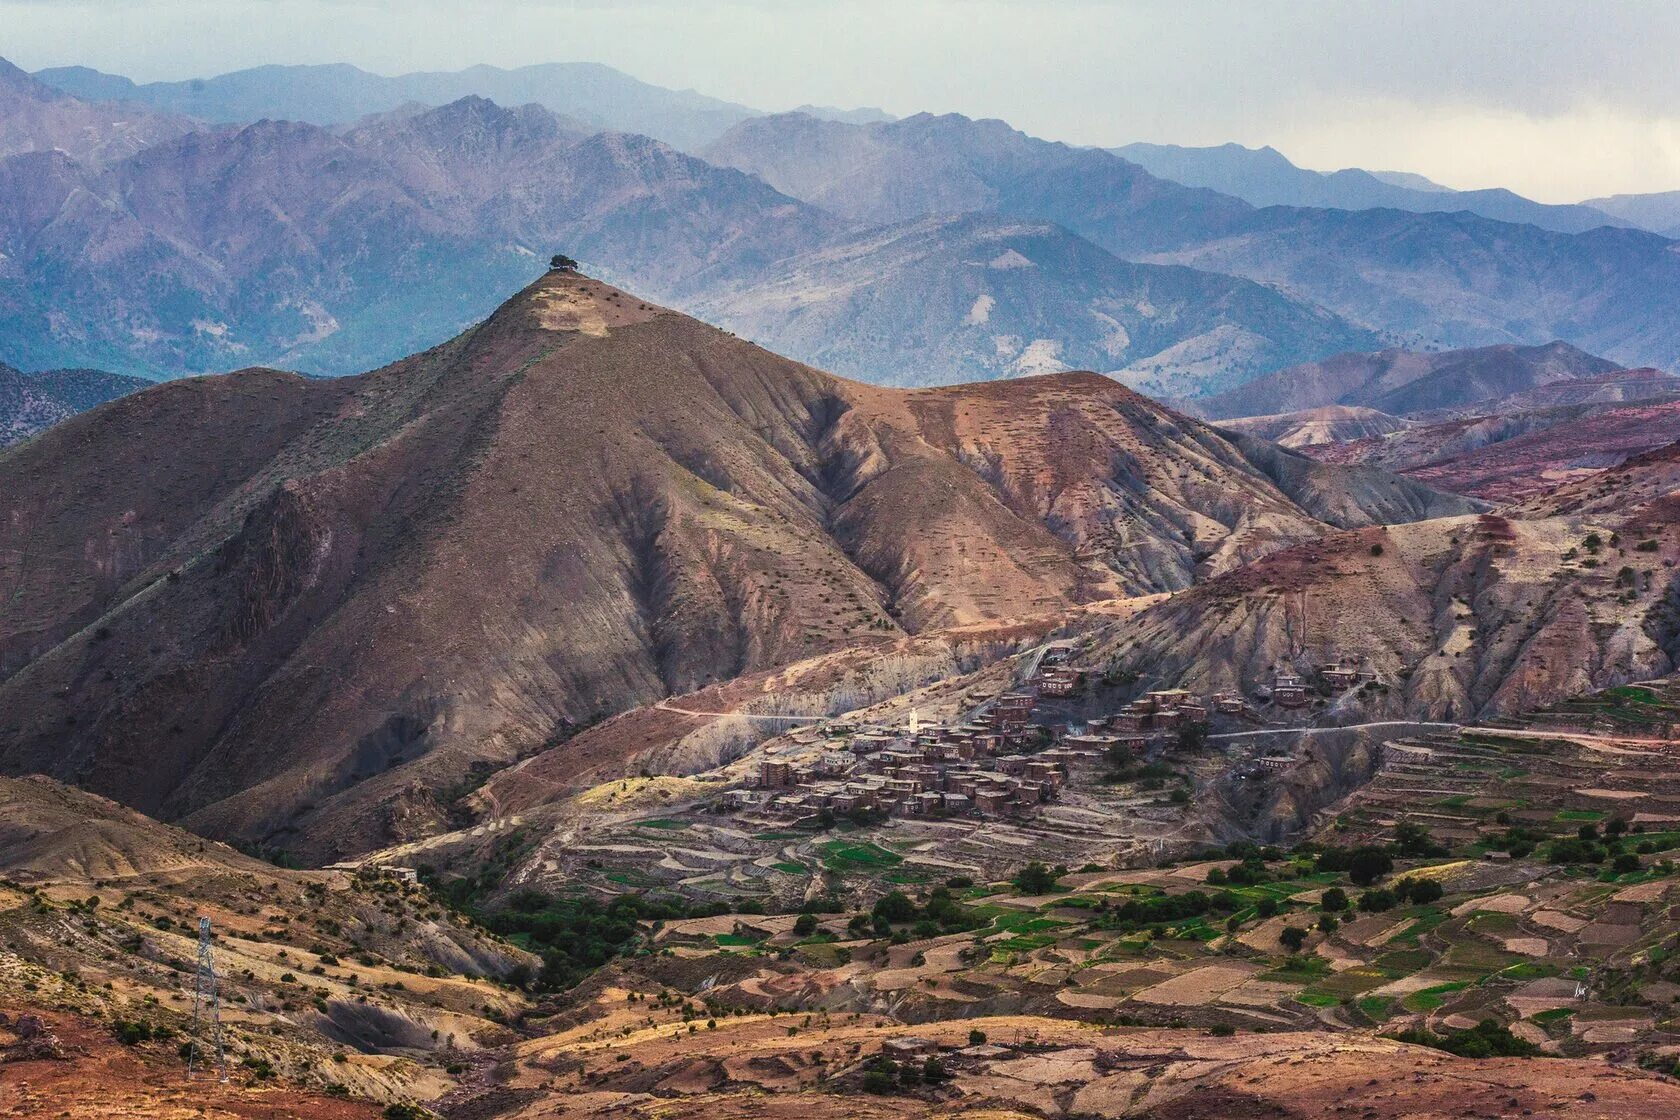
0,776,531,1120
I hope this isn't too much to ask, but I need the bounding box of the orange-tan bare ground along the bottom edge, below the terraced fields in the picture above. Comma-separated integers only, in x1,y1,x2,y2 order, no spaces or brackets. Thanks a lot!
457,989,1680,1120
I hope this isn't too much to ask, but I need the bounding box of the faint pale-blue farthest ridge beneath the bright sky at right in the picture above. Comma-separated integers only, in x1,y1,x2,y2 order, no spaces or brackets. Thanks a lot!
1109,143,1632,233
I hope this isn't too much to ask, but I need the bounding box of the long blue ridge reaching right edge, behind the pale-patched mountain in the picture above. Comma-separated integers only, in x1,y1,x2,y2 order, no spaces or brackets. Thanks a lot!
704,114,1680,376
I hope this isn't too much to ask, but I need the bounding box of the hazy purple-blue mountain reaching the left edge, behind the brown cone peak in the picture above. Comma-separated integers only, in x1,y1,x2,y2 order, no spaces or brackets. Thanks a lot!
0,97,842,374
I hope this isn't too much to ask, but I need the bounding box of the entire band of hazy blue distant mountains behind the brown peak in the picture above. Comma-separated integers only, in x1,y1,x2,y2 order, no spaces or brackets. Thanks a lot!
0,64,1680,396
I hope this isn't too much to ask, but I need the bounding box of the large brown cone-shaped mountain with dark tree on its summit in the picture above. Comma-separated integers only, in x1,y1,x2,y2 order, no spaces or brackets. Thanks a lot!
0,272,1465,856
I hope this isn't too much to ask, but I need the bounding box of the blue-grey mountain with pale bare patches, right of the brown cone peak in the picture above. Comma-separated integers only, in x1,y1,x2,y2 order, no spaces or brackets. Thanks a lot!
690,215,1376,396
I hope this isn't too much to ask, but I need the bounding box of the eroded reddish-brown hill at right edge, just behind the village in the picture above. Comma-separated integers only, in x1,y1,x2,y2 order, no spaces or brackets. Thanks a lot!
1095,505,1680,720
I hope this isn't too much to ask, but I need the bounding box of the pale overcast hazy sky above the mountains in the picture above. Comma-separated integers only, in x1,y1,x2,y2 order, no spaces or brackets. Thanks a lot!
0,0,1680,201
